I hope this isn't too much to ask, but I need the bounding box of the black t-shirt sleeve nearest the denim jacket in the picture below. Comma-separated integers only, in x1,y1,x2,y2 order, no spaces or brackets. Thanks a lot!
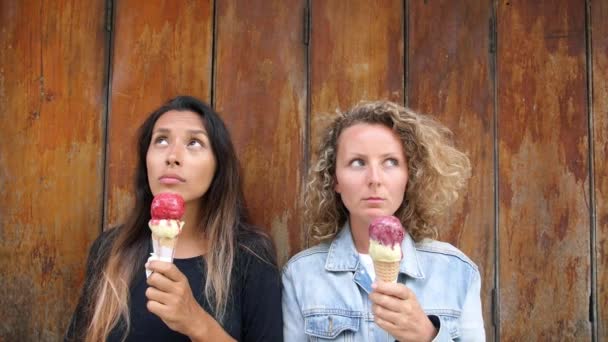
241,247,283,342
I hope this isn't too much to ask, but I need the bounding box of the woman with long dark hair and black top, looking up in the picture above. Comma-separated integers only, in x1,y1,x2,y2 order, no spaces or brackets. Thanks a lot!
65,96,283,341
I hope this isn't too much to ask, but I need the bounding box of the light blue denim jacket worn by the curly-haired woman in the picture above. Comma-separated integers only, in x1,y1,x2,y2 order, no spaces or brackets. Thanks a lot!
282,223,485,342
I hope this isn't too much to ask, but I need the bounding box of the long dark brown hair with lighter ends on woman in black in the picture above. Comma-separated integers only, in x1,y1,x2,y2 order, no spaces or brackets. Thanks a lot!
86,96,276,341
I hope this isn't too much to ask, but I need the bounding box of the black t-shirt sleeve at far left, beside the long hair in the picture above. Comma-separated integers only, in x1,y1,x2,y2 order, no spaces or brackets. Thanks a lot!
64,229,116,342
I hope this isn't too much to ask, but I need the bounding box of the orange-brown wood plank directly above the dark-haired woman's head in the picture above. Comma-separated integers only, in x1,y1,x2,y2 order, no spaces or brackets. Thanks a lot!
105,0,213,227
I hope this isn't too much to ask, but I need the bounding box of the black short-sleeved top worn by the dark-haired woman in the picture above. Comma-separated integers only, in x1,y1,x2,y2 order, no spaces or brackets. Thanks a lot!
65,229,283,342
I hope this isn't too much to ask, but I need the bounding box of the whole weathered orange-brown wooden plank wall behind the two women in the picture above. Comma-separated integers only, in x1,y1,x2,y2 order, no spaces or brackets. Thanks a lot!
0,0,608,341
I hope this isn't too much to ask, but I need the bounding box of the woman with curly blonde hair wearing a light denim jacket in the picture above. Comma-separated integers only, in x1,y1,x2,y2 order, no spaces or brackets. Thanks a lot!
282,101,485,341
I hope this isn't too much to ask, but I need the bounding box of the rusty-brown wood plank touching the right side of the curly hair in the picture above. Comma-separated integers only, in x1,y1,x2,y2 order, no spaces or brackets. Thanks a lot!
406,0,495,340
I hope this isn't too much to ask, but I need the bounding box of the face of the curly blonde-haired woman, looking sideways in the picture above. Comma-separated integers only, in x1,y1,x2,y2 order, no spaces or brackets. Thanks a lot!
335,123,408,226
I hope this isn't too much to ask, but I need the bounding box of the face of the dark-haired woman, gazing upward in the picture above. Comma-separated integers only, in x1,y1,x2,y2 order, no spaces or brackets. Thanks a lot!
146,110,216,202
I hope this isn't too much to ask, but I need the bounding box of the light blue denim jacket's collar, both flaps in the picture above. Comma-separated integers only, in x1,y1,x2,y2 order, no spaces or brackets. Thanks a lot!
325,222,424,279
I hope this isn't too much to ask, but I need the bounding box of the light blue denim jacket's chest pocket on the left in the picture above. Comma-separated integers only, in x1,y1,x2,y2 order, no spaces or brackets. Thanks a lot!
304,310,361,341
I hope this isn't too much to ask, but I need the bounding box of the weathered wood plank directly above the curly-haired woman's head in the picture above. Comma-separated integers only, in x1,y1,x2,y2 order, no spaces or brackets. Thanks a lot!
309,0,404,155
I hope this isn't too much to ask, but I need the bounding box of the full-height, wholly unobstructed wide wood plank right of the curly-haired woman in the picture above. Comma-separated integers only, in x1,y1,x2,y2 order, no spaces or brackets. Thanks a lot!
497,0,591,341
